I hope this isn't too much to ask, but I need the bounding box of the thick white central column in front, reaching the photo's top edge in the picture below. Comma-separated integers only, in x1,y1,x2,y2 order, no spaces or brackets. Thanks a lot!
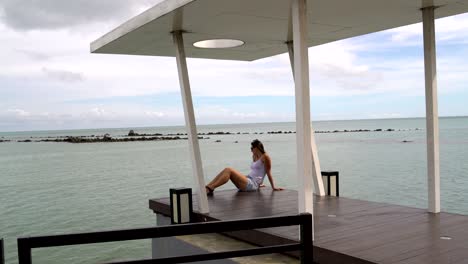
291,0,314,223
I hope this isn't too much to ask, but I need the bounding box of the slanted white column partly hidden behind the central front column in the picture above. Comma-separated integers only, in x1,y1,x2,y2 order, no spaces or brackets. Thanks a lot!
286,41,325,196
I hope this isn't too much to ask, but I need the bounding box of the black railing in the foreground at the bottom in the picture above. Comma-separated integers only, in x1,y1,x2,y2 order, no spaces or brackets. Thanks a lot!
18,214,313,264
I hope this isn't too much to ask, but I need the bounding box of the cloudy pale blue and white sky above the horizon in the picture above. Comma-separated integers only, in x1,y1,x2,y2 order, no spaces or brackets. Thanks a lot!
0,0,468,131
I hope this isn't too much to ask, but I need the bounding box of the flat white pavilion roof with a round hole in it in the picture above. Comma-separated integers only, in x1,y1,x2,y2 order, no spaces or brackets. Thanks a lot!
91,0,468,61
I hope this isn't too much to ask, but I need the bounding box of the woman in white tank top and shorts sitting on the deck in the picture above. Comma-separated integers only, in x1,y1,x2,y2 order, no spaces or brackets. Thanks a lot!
206,139,283,195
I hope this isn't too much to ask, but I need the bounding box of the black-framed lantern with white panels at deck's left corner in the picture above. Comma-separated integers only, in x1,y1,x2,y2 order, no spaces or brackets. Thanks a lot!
169,188,193,224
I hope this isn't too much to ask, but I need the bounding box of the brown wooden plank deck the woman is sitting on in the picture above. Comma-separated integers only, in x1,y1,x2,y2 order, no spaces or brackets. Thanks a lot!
149,189,468,264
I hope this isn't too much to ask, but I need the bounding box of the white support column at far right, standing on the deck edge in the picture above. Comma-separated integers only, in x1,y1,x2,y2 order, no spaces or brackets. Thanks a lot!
422,7,440,213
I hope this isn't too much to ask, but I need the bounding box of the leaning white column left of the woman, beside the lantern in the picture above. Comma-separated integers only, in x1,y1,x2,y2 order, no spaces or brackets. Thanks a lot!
173,31,209,213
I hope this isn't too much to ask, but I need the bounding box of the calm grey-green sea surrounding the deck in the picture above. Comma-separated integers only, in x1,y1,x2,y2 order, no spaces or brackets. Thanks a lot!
0,117,468,264
